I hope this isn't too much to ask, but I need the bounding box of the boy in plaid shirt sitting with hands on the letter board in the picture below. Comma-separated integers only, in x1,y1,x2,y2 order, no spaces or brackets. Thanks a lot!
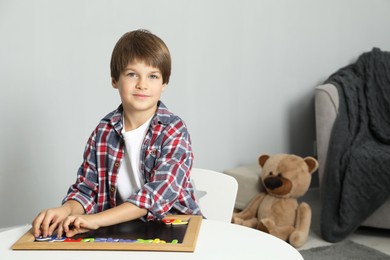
32,30,201,237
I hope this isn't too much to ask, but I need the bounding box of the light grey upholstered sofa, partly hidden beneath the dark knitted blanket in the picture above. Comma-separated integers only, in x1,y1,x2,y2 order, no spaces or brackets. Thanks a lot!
315,84,390,229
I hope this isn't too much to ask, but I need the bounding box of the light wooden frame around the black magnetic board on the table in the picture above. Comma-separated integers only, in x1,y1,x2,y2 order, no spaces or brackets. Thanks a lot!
11,215,202,252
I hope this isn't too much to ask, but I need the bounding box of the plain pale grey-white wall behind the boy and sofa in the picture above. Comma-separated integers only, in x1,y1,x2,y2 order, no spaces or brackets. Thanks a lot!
0,0,390,227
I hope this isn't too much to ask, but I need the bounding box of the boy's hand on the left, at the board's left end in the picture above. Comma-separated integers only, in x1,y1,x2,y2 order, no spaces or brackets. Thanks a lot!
32,206,71,237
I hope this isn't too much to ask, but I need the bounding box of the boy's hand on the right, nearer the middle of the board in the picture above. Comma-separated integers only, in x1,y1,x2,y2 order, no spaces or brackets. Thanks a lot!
57,215,100,237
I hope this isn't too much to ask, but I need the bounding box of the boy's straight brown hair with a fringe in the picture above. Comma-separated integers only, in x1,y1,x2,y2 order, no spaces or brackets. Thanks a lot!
110,29,171,84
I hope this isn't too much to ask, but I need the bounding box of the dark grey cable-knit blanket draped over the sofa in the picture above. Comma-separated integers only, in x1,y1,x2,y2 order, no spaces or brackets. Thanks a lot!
321,48,390,242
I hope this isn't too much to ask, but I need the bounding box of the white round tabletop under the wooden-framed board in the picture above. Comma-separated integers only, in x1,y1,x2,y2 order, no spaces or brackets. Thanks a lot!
0,220,303,260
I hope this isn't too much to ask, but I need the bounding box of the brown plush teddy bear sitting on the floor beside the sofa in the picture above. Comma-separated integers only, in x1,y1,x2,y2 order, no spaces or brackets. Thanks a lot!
232,154,318,248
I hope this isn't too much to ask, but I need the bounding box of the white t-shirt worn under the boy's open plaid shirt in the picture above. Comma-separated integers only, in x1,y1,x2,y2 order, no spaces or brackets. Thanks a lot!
117,117,152,201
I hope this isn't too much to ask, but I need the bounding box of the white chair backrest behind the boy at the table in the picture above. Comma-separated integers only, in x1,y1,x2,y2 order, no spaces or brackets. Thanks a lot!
190,168,238,223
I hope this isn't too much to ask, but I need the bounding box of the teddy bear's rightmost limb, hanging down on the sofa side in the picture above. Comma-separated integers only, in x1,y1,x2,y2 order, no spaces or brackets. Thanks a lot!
289,202,311,247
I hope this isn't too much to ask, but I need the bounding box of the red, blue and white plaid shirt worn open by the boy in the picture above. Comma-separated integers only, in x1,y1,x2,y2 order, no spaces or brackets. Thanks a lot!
63,101,201,220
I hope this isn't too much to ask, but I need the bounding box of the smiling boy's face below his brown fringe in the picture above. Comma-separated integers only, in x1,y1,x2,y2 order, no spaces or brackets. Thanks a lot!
112,61,166,117
